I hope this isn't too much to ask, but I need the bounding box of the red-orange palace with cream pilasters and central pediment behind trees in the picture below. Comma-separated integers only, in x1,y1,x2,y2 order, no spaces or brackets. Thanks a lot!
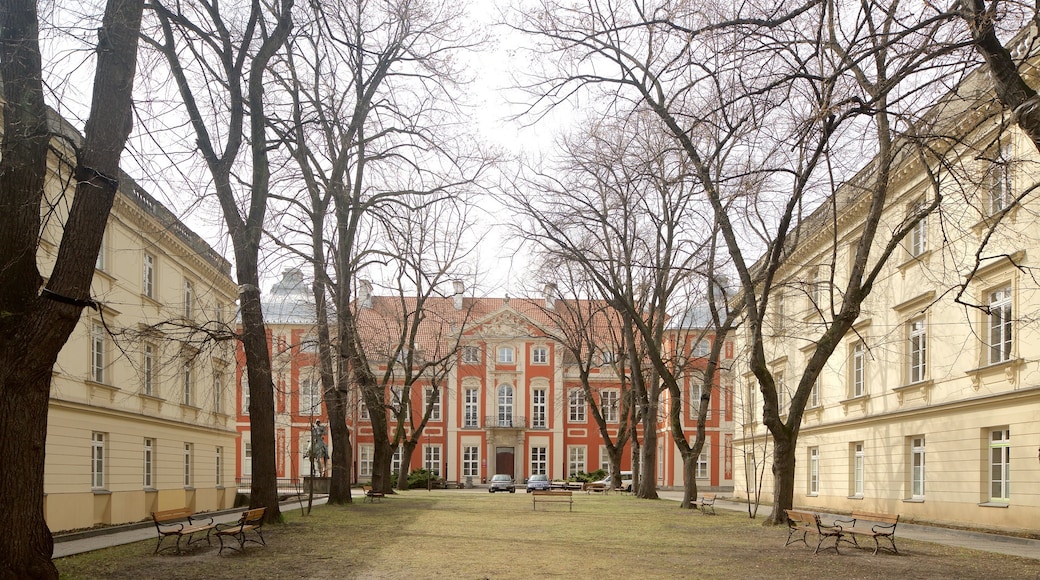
238,270,733,490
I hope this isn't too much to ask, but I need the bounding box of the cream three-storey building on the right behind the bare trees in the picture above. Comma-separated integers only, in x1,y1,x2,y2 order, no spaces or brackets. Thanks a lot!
734,61,1040,529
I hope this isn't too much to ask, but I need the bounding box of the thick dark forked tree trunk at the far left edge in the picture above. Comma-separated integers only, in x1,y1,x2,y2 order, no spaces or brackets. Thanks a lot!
0,0,144,579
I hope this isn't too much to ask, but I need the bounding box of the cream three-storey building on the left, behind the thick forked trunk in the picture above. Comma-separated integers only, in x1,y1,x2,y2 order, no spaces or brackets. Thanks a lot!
38,115,237,531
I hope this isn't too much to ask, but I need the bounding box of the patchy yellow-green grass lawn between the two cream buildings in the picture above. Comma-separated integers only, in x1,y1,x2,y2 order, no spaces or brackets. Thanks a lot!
56,491,1040,580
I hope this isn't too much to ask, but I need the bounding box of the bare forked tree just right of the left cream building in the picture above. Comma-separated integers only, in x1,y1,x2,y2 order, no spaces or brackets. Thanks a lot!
146,0,293,522
